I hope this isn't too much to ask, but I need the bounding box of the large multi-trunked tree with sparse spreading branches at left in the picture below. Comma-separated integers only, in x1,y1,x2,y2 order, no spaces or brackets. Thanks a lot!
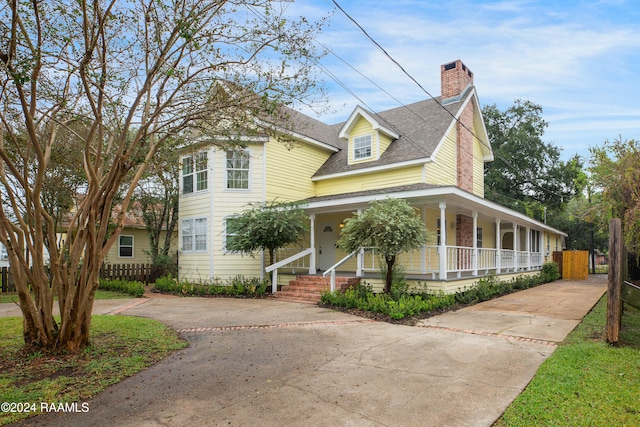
0,0,323,352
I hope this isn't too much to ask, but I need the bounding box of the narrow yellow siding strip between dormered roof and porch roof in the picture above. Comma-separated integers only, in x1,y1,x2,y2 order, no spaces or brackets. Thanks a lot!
316,165,423,196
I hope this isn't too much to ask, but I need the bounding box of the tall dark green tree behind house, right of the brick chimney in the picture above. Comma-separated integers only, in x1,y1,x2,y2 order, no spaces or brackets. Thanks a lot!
482,100,584,220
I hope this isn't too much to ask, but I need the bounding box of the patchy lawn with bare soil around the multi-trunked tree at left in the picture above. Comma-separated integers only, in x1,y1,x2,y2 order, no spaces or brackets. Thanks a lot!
0,316,187,425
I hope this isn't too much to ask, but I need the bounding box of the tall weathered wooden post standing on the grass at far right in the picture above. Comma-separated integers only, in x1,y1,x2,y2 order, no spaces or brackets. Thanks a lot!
607,218,627,344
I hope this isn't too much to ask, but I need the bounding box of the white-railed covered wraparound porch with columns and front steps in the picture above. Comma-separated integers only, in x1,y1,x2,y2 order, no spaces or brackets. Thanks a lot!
265,186,566,292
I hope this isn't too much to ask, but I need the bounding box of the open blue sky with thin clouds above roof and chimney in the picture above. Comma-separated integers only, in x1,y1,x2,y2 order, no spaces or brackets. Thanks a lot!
288,0,640,160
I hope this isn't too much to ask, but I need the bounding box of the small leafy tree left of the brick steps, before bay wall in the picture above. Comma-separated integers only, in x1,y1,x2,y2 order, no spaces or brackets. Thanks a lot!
226,201,309,270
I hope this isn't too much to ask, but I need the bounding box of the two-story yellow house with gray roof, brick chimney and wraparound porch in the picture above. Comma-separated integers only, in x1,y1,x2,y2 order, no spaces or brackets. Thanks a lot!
179,61,566,292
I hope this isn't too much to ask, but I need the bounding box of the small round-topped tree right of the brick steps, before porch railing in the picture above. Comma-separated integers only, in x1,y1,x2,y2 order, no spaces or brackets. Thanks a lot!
337,199,427,293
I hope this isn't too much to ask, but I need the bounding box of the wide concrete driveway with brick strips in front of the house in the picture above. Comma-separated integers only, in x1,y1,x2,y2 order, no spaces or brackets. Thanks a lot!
10,276,606,427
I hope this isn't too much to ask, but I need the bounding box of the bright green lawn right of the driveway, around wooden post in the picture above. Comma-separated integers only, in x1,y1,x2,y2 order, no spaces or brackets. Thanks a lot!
495,296,640,427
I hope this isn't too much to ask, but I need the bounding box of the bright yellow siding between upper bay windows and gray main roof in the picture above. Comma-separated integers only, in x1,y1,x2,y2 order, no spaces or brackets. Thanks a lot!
266,140,332,201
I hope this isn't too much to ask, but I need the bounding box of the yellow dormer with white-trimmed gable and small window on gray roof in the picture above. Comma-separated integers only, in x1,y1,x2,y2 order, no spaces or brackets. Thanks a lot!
338,106,400,165
